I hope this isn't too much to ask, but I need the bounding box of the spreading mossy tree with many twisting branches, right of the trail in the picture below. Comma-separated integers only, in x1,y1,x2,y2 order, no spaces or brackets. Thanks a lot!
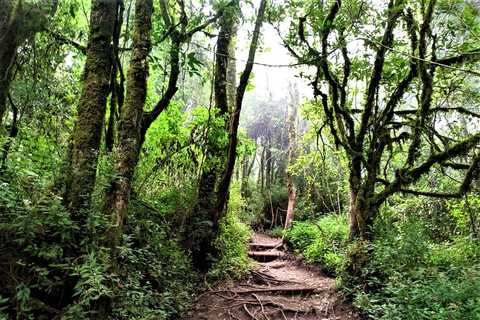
285,0,480,280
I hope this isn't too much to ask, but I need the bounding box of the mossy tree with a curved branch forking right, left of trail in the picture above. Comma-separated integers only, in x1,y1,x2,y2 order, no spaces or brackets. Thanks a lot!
103,0,217,248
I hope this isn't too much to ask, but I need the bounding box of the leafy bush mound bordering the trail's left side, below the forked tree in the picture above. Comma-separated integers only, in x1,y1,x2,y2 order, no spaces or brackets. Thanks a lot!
109,210,193,319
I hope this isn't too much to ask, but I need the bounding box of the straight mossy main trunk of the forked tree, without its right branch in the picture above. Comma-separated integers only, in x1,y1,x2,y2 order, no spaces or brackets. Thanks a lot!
103,0,153,248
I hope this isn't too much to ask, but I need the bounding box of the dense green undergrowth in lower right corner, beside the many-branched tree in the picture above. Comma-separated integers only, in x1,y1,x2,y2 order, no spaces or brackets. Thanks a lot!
343,209,480,320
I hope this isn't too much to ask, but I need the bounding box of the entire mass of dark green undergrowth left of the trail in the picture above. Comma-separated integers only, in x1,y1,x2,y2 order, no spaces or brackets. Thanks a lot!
0,172,193,320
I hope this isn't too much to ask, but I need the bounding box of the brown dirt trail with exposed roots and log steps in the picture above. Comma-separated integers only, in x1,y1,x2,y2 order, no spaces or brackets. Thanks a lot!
185,233,361,320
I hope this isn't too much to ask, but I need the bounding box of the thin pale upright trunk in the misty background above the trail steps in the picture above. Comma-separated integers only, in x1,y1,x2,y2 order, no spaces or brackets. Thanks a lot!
285,84,299,230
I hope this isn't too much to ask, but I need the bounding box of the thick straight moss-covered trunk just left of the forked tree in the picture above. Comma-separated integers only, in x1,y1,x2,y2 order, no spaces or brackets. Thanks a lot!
66,0,117,215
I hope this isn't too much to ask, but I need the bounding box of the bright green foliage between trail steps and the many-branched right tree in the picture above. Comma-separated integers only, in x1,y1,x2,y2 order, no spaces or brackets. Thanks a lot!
285,215,348,274
